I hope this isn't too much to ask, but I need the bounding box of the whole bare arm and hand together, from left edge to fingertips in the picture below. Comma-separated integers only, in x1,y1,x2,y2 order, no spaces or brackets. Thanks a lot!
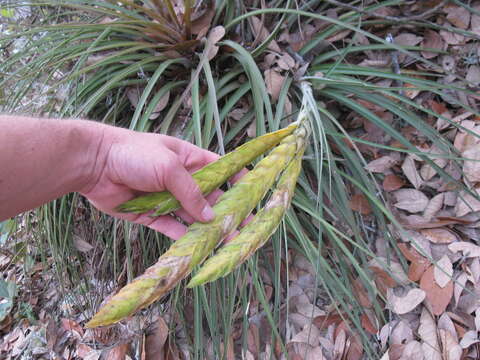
0,115,229,239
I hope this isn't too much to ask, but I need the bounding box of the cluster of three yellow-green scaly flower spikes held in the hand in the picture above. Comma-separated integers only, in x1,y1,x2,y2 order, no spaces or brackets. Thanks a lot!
87,85,311,327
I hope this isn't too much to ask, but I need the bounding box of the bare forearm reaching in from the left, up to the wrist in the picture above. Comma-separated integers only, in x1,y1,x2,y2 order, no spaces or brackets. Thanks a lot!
0,115,103,221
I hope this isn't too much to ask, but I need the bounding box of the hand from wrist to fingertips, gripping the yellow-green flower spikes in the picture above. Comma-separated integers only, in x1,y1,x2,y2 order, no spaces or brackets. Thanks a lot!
80,127,221,239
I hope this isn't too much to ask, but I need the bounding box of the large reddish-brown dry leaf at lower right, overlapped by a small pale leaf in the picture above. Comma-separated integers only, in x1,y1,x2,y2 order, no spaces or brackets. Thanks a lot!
420,265,453,315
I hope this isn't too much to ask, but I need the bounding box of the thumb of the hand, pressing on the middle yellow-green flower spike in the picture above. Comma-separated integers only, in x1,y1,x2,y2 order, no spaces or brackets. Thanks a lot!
159,155,215,222
